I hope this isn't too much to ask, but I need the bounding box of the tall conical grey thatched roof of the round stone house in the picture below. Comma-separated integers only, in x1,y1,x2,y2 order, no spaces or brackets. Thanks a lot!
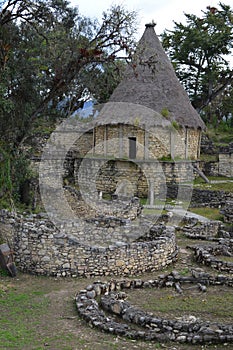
109,24,205,129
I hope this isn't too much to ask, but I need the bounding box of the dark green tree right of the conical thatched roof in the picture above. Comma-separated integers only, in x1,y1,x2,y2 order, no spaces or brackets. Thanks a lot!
162,3,233,122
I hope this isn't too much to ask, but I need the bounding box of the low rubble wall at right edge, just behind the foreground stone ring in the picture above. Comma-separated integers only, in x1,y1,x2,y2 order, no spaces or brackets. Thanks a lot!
189,239,233,274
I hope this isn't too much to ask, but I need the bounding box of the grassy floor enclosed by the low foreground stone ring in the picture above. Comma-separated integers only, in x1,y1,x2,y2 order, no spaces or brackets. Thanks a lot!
127,285,233,324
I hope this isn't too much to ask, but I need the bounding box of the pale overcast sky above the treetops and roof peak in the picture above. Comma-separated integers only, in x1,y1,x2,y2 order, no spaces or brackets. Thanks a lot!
70,0,226,37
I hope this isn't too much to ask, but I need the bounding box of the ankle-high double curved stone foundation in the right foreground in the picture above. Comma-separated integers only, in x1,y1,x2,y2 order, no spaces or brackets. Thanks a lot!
76,270,233,344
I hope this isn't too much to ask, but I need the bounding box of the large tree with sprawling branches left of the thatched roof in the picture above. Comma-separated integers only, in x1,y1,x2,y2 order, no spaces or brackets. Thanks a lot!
0,0,136,206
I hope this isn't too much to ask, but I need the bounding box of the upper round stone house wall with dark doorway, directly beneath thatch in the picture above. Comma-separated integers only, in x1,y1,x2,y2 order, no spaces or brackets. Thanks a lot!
92,124,200,160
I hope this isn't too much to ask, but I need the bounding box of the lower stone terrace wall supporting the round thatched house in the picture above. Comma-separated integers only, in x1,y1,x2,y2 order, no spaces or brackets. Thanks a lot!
74,158,195,197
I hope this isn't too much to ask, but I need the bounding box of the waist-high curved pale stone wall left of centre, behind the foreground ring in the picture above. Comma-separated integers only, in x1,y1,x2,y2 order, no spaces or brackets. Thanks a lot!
1,210,178,277
